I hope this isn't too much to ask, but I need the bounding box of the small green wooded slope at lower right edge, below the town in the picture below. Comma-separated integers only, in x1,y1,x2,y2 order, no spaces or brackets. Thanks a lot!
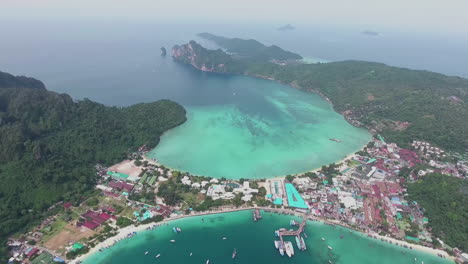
408,174,468,251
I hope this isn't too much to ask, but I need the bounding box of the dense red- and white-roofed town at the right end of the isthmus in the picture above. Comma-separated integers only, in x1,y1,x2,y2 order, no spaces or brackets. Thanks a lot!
282,138,466,252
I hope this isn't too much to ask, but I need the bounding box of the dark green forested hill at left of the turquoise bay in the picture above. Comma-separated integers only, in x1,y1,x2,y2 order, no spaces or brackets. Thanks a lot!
0,70,186,262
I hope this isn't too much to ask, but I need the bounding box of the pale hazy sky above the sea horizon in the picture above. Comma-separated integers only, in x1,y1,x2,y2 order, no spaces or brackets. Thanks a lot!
0,0,468,35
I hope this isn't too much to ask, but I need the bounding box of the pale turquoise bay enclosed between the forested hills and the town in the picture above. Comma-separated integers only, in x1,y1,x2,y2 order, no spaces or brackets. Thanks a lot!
149,74,370,179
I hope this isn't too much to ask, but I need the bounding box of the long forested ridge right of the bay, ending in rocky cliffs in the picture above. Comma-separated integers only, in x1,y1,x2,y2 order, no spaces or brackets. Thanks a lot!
173,38,468,152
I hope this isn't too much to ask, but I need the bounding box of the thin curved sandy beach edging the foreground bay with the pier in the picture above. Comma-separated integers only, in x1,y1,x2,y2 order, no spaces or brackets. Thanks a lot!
70,207,455,264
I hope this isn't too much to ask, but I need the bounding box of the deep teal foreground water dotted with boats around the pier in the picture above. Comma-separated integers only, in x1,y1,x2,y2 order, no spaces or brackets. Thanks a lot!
85,211,451,264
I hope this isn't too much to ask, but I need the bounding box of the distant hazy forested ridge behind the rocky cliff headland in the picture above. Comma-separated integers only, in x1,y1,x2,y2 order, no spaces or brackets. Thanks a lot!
198,33,302,61
